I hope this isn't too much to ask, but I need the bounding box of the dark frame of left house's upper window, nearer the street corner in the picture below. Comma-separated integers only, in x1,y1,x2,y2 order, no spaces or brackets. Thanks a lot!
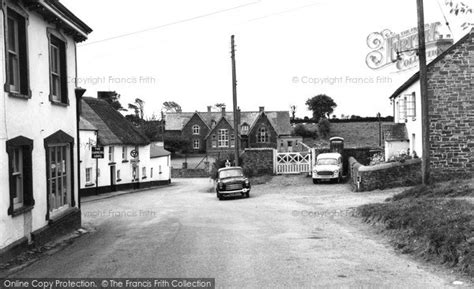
47,28,70,106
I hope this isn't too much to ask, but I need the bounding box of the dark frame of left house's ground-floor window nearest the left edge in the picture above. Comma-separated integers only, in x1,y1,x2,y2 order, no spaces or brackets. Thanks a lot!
6,136,35,217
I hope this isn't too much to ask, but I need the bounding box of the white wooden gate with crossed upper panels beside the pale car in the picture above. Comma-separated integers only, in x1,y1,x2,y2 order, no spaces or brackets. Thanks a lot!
274,151,312,175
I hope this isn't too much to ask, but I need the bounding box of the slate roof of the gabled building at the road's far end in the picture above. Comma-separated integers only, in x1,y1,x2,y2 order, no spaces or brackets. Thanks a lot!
165,111,291,135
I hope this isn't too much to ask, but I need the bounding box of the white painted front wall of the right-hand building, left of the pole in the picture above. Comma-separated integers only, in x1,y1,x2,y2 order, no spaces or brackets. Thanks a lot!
393,81,423,157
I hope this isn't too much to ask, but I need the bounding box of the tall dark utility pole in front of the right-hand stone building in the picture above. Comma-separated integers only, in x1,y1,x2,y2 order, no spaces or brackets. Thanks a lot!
416,0,430,185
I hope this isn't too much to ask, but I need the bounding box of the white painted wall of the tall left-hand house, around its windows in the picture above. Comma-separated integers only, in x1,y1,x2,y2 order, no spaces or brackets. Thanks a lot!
0,11,79,249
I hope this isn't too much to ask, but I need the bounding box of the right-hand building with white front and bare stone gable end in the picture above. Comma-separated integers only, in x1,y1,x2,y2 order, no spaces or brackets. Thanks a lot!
390,29,474,180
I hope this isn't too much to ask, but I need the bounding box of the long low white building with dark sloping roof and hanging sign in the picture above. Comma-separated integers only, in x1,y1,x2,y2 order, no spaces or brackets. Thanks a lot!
80,97,171,196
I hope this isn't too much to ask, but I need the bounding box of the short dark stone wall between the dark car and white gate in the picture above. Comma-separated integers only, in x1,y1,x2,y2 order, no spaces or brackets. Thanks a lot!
241,148,274,177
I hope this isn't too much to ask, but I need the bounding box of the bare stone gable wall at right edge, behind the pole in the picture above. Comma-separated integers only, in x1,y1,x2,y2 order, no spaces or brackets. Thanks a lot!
428,30,474,181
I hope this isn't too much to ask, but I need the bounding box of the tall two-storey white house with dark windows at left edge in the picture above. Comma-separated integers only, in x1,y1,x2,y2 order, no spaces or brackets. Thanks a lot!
0,0,92,258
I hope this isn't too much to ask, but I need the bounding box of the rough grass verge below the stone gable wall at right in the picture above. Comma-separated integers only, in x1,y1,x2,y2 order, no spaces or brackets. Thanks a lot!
357,182,474,278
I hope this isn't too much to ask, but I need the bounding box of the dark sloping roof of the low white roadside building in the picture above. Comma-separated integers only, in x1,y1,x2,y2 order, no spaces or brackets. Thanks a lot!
81,97,150,145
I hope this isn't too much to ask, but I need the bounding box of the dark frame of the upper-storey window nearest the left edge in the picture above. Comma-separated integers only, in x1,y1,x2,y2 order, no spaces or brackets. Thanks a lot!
2,2,31,99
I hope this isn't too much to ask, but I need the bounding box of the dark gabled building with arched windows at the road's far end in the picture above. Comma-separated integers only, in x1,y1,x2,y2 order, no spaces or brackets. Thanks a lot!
165,107,291,154
